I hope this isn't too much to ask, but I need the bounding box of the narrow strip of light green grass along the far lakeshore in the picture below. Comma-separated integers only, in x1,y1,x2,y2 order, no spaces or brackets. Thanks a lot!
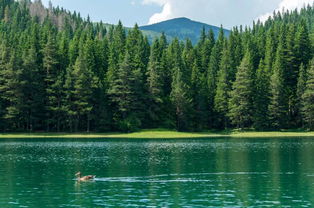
0,130,314,139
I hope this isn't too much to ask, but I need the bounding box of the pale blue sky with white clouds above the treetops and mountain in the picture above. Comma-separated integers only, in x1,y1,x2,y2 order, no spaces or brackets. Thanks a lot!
42,0,314,29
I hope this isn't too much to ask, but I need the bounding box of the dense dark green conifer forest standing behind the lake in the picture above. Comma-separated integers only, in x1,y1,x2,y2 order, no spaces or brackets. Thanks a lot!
0,0,314,132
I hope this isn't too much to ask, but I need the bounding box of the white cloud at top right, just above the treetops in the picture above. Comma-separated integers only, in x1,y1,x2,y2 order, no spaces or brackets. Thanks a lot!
257,0,314,22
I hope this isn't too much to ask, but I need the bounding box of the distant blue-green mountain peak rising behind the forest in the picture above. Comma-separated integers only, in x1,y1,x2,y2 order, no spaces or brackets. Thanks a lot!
140,17,230,44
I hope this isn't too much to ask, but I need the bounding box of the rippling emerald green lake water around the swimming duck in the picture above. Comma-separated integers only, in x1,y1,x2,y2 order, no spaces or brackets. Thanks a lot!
0,138,314,208
